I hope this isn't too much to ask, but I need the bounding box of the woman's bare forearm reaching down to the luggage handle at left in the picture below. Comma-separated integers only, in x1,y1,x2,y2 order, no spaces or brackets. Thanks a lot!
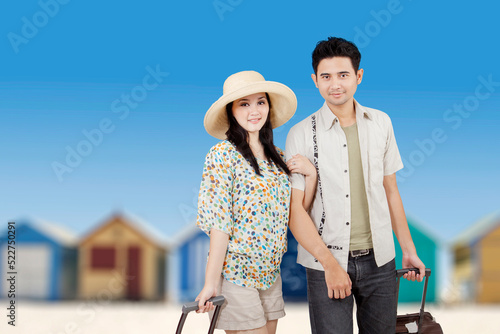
196,229,229,313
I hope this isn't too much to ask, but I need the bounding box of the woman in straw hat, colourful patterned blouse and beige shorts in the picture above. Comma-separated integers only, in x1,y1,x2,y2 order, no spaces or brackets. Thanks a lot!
196,71,316,334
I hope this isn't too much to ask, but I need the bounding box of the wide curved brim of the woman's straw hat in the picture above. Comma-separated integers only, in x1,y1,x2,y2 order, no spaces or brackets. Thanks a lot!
203,81,297,139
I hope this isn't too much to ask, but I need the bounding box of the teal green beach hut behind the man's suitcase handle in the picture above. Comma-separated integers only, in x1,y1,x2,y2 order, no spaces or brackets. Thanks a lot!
394,216,443,303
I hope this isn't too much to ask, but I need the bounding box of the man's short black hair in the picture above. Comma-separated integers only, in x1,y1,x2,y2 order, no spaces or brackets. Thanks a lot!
312,37,361,74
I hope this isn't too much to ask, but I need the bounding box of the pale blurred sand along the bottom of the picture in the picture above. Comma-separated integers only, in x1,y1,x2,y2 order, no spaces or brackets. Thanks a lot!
0,300,500,334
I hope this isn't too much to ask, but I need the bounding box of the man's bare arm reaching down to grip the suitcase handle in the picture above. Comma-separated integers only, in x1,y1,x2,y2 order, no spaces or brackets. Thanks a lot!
384,174,425,282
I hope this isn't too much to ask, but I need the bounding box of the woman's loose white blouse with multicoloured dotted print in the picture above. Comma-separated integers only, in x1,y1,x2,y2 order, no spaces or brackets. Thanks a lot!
196,140,290,290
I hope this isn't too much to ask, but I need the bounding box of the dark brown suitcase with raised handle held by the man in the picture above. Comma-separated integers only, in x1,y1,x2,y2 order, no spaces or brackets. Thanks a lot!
396,268,443,334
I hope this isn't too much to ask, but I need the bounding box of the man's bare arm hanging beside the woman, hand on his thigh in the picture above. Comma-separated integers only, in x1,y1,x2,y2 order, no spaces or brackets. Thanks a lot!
289,189,352,299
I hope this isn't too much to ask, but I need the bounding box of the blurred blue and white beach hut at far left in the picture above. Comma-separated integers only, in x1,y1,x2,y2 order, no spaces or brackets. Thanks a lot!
0,218,77,300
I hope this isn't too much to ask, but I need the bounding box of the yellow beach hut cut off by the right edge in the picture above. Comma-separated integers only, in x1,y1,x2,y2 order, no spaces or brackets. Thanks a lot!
452,212,500,303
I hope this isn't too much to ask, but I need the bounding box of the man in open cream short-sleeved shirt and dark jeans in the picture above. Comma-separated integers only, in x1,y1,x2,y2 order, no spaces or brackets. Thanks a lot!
286,37,425,334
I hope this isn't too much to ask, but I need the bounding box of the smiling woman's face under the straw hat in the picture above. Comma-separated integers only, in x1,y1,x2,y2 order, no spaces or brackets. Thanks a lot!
233,93,269,134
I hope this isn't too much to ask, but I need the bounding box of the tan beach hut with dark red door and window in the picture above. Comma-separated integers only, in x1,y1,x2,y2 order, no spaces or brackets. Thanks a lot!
78,212,167,300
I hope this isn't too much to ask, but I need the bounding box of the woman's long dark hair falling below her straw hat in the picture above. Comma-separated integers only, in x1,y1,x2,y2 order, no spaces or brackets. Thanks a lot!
226,93,290,175
